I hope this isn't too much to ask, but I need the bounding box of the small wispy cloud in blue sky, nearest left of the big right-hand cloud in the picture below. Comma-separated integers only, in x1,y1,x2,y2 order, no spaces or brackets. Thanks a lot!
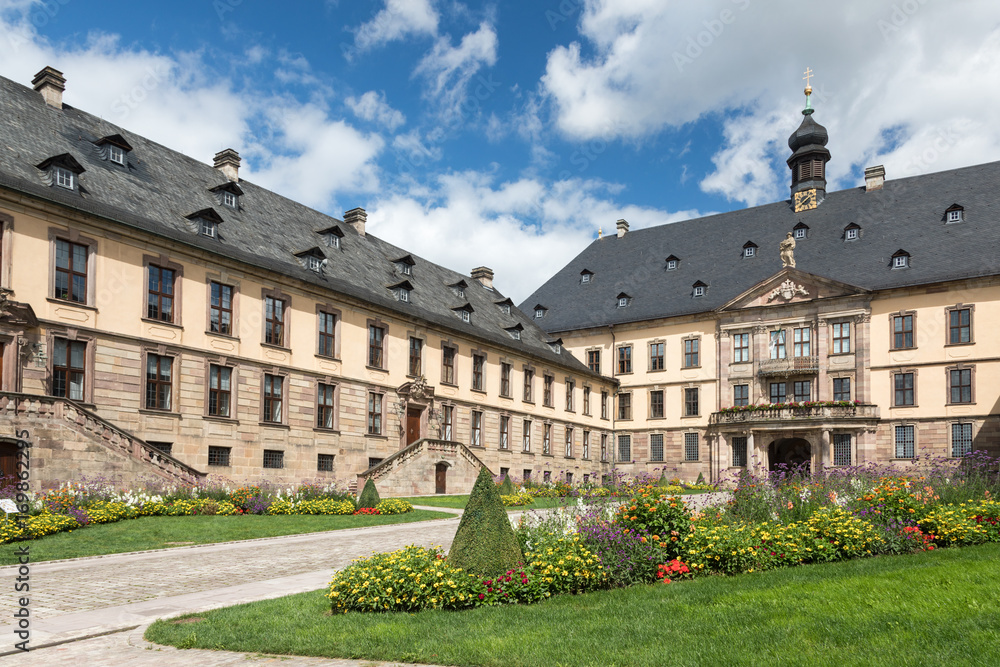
414,21,498,119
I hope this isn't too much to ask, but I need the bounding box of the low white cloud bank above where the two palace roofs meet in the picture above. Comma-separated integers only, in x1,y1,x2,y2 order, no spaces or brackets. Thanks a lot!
368,172,699,301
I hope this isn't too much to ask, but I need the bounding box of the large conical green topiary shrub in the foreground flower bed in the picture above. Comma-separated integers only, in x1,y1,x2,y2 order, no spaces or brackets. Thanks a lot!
448,467,524,577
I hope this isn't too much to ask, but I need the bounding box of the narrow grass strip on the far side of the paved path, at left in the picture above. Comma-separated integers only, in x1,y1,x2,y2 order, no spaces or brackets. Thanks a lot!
0,510,454,565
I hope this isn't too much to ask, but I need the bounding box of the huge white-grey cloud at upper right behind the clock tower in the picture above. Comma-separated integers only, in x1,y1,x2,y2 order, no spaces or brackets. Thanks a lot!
542,0,1000,203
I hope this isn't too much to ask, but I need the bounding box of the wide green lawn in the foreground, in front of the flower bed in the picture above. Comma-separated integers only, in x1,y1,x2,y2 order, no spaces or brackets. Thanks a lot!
146,544,1000,667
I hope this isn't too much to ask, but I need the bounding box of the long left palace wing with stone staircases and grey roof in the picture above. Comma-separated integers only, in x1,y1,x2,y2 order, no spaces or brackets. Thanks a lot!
0,68,616,493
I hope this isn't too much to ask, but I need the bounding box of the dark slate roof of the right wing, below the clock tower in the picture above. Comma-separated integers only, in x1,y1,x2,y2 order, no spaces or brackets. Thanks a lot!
521,162,1000,332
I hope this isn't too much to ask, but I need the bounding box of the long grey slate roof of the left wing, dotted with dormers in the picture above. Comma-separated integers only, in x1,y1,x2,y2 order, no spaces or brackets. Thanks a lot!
0,72,599,377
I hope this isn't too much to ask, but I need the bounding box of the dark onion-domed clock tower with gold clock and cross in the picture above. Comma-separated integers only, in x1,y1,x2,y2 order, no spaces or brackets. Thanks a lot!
788,68,830,212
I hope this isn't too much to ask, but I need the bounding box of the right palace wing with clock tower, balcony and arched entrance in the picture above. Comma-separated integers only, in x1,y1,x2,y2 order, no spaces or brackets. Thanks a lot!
522,83,1000,480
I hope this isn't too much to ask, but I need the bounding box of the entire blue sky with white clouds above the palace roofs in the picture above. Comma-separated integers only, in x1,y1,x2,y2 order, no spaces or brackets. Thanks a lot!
0,0,1000,300
